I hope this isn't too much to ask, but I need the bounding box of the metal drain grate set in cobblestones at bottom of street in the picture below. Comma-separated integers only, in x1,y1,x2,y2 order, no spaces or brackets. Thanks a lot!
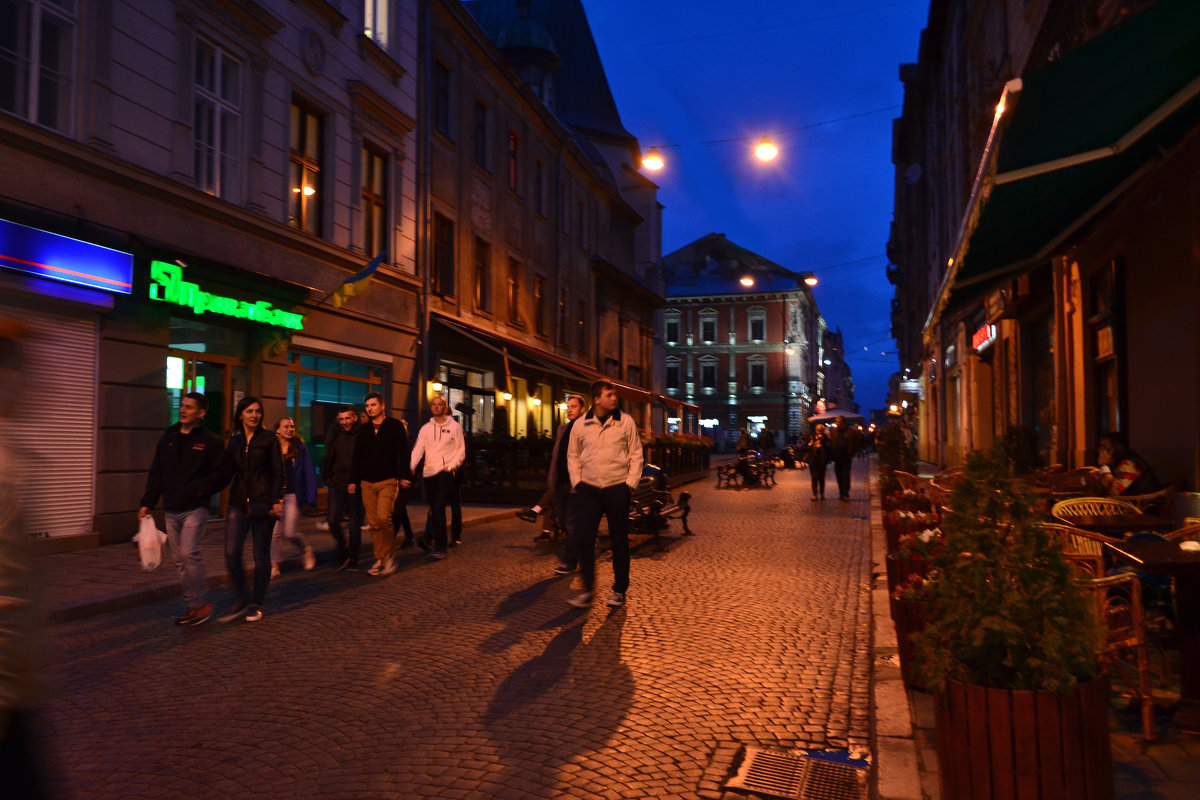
725,747,866,800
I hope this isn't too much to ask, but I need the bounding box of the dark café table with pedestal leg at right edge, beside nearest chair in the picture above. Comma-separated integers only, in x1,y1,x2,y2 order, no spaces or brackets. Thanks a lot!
1104,541,1200,734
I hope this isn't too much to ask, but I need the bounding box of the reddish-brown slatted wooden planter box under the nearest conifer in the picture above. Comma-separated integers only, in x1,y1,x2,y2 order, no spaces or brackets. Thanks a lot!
937,675,1114,800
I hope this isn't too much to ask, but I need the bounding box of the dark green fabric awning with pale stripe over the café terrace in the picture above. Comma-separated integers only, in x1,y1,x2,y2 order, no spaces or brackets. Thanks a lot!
926,0,1200,333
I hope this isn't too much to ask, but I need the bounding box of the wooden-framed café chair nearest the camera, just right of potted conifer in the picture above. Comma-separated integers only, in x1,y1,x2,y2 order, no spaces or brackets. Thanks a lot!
1080,573,1156,742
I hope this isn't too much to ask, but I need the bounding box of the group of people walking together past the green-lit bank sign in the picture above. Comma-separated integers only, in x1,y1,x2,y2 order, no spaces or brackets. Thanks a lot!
138,392,467,625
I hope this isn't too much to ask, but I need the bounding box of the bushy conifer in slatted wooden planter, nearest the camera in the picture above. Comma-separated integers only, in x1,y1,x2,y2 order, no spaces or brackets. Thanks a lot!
913,449,1112,800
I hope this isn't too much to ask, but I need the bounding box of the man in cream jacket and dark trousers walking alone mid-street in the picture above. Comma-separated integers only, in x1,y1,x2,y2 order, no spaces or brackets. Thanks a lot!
566,380,642,608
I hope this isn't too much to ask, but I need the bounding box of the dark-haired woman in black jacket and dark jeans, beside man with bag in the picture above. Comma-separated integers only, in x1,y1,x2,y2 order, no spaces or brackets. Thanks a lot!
221,397,283,622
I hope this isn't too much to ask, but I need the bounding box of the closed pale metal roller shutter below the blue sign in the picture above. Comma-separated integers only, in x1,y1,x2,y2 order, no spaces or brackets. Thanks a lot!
0,303,98,539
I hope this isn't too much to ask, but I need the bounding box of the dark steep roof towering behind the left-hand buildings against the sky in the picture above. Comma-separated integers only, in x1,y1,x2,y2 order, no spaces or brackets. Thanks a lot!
462,0,637,146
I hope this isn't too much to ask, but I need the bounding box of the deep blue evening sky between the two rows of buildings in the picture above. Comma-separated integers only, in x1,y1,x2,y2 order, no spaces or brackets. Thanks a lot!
583,0,929,409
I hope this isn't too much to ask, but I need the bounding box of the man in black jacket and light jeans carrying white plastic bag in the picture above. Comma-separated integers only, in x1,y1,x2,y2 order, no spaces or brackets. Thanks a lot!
138,392,228,625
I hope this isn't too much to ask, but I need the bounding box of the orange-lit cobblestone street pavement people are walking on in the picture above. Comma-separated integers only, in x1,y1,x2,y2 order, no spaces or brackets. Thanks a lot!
30,462,871,800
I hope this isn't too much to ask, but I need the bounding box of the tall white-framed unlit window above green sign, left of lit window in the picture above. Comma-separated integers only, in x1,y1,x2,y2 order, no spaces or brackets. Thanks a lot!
192,40,241,199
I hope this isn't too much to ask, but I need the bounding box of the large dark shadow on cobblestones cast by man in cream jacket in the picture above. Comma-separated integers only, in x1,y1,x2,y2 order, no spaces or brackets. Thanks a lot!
480,608,634,799
